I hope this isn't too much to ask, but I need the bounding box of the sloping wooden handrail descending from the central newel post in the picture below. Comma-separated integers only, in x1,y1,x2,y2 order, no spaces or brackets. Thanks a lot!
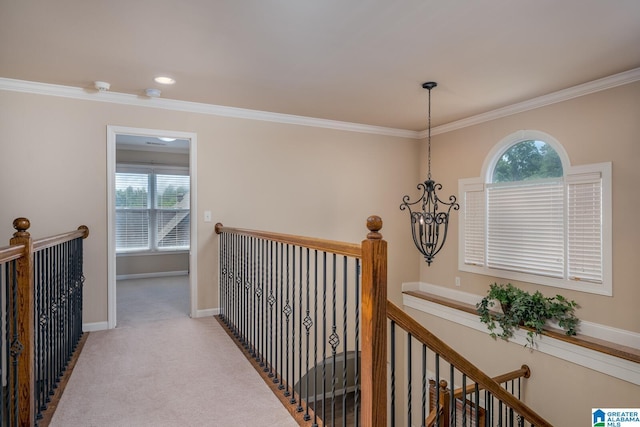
387,301,551,427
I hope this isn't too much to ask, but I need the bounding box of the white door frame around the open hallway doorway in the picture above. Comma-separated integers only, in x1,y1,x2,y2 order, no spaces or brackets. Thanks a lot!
107,125,198,329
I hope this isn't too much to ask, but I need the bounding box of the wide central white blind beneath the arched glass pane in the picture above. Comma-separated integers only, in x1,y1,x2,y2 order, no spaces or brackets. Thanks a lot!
487,181,564,278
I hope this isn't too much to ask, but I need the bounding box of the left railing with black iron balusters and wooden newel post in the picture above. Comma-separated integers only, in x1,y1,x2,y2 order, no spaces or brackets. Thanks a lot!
0,218,89,427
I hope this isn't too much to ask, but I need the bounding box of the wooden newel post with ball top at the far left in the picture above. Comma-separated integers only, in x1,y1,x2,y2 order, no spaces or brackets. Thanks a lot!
10,218,35,426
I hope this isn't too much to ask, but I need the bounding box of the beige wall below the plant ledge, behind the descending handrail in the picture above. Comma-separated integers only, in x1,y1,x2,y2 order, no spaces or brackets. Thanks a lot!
405,307,640,427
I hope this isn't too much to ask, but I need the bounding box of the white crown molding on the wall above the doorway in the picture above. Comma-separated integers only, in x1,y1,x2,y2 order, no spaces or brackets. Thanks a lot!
0,77,419,139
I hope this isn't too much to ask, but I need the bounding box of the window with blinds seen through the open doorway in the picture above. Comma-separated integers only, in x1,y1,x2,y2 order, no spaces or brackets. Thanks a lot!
115,165,190,253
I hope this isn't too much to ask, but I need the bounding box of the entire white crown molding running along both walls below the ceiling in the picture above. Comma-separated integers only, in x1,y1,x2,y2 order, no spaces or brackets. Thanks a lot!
0,68,640,139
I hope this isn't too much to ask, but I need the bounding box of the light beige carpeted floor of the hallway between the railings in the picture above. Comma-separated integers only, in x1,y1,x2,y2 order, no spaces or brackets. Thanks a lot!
50,283,298,427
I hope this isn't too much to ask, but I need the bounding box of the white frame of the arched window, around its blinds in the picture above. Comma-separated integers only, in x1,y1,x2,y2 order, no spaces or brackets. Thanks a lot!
458,130,613,296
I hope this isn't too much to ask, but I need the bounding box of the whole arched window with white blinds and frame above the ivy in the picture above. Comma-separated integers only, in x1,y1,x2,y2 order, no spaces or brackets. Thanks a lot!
458,131,611,295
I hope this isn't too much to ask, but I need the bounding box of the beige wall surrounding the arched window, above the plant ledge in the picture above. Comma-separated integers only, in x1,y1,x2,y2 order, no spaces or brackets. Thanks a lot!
420,83,640,333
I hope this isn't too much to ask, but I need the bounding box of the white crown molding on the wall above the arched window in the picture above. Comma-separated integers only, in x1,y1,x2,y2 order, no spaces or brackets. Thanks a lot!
418,68,640,139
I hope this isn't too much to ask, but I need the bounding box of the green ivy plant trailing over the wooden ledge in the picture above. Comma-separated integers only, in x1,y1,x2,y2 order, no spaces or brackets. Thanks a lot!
476,283,580,348
